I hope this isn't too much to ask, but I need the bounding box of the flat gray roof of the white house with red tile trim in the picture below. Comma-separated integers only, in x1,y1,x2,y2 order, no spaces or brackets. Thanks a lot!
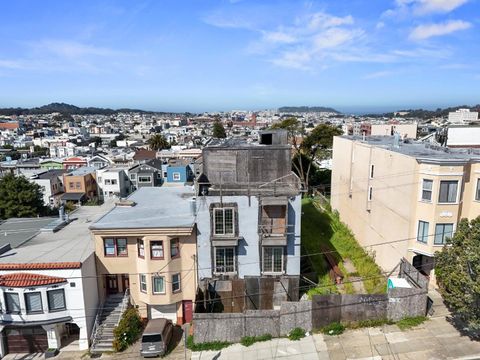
0,201,114,264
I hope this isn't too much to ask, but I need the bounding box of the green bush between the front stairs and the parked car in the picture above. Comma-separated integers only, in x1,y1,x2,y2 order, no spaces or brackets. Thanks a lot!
113,307,143,351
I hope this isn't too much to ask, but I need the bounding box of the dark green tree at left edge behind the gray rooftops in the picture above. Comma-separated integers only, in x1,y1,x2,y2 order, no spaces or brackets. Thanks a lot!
0,174,46,219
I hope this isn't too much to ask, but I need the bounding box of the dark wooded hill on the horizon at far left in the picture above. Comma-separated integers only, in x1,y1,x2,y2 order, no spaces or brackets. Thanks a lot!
0,103,161,116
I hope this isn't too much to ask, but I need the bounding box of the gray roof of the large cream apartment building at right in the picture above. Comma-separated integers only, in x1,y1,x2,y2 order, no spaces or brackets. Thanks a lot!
341,135,480,163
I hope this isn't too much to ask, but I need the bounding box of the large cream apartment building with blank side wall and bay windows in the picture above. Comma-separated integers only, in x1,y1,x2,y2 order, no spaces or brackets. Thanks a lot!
331,136,480,276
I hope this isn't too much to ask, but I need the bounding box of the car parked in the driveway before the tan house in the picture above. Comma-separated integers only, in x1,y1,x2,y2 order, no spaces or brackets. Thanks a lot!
140,319,173,357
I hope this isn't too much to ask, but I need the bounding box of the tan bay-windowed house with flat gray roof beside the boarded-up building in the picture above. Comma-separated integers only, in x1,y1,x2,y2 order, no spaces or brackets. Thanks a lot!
90,186,197,323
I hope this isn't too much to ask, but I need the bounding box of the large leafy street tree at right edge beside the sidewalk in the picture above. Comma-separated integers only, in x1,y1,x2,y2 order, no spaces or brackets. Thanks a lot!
435,216,480,334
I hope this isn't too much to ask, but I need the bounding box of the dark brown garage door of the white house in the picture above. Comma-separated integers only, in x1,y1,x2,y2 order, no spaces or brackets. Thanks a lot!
5,326,48,354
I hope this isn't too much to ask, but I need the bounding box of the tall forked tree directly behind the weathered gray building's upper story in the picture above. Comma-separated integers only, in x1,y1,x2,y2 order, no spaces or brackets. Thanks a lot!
272,117,342,191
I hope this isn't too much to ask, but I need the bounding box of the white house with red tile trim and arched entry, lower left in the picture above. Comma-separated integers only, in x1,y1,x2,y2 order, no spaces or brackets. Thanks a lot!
0,205,110,357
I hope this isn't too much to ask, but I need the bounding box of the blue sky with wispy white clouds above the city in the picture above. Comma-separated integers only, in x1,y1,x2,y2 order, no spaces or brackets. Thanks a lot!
0,0,480,112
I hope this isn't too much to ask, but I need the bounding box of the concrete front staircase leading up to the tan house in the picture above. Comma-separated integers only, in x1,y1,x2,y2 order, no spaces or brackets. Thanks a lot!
90,294,128,353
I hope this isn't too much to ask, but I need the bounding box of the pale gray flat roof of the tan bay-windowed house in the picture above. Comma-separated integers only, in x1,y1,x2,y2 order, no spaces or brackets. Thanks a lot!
90,186,195,230
